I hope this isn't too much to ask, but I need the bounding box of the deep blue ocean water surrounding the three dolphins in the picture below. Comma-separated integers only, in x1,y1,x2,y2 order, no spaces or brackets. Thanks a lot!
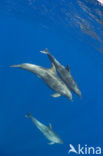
0,0,103,156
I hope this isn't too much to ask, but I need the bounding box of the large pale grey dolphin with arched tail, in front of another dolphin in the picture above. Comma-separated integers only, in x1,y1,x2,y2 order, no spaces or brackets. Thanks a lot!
11,63,72,100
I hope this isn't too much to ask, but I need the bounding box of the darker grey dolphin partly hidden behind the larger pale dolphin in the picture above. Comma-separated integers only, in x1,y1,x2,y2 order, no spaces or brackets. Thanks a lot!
40,49,81,97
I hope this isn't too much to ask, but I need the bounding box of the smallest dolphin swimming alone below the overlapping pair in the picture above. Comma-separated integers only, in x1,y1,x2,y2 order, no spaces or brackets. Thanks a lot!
26,113,63,145
